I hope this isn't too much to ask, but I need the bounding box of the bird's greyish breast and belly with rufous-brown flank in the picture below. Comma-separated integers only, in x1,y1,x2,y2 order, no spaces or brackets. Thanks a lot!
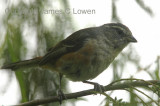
56,39,117,81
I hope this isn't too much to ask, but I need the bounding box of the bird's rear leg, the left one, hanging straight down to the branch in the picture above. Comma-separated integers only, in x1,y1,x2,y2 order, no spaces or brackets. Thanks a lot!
58,73,66,104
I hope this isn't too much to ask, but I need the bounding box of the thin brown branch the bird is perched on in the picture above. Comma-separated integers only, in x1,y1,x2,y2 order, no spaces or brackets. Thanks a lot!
16,79,160,106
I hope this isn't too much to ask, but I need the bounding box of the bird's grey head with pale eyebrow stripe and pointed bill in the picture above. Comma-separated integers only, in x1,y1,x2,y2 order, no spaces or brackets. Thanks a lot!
101,23,137,49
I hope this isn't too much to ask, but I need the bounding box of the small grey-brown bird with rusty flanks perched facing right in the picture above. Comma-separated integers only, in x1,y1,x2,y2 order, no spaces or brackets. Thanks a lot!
2,23,137,102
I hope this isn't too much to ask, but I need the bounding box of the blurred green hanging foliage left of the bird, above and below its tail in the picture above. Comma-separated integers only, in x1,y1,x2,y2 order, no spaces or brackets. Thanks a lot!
0,0,74,106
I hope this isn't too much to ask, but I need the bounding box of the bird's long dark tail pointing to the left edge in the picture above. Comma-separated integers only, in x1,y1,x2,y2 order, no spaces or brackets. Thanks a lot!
1,57,41,70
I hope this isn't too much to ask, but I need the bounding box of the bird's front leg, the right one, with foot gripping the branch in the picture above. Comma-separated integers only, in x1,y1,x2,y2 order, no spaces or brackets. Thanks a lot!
82,81,105,93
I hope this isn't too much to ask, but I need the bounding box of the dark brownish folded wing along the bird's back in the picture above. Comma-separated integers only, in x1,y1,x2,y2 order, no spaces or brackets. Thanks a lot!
39,28,95,65
